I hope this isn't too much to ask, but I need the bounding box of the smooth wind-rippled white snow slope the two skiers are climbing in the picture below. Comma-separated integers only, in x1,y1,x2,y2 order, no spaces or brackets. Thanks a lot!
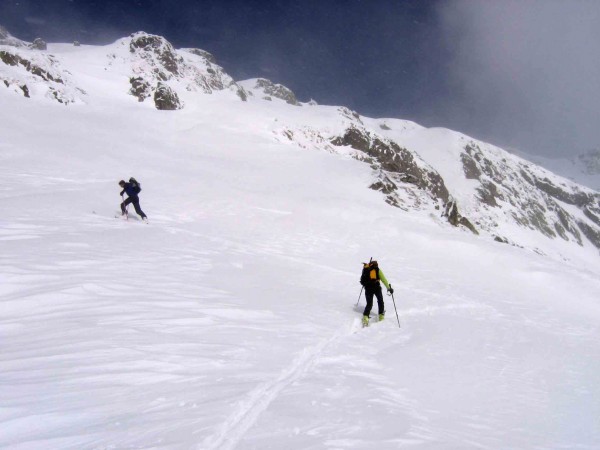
0,46,600,450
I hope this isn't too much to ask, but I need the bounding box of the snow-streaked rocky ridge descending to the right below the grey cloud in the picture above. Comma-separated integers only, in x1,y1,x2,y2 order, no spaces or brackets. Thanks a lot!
275,108,600,249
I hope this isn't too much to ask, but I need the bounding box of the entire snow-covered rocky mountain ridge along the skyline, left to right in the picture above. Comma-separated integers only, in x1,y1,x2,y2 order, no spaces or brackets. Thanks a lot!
0,32,600,258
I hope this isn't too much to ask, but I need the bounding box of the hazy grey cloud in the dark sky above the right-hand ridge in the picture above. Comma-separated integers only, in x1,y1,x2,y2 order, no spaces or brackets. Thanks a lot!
438,0,600,156
